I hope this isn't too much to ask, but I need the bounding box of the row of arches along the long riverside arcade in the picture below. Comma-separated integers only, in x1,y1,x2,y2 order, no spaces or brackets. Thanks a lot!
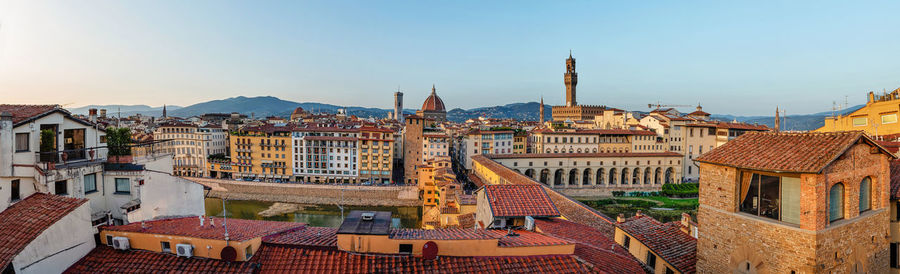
516,167,676,186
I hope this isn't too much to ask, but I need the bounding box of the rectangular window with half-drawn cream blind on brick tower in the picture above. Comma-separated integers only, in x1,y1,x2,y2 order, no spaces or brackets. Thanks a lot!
739,173,800,224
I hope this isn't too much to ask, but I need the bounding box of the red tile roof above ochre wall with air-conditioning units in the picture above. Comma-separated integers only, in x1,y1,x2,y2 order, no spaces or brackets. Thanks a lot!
102,216,304,242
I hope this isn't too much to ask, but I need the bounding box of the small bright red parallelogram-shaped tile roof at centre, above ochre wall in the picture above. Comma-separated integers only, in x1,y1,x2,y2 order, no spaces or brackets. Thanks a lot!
479,184,559,217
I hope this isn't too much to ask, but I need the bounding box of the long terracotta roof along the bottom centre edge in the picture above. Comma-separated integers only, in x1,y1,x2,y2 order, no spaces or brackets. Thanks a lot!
250,244,592,273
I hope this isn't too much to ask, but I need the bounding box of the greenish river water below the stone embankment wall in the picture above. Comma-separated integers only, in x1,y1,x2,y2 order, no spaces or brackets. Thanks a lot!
206,198,422,228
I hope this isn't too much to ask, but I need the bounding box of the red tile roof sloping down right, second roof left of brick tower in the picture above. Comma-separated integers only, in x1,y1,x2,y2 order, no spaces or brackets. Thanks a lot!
535,218,643,273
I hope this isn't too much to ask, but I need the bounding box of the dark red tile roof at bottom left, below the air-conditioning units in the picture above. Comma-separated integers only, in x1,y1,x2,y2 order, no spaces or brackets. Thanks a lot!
63,245,256,273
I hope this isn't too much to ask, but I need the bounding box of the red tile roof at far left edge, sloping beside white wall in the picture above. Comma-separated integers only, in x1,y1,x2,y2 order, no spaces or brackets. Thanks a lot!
0,193,87,266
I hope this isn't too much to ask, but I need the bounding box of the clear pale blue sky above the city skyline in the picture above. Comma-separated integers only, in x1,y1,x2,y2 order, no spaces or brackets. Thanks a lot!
0,0,900,115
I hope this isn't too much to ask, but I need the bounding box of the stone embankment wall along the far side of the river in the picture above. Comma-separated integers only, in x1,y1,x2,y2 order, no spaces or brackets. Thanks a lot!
185,178,422,207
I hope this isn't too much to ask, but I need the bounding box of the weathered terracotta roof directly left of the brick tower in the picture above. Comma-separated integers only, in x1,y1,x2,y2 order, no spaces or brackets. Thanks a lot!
619,215,697,273
